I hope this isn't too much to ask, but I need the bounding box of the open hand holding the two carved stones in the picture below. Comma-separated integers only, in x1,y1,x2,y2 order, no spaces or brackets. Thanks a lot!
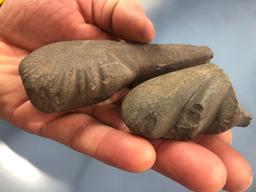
0,0,252,192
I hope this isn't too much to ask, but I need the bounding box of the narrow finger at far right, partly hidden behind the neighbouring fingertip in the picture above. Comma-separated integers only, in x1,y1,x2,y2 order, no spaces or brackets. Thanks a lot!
198,136,252,191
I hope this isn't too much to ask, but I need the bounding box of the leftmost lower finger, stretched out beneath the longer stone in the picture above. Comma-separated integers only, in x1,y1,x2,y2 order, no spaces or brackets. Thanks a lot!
41,113,155,172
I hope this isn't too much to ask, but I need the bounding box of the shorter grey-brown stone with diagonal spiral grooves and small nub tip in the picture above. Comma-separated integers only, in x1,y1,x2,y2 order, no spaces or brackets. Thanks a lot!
122,64,251,140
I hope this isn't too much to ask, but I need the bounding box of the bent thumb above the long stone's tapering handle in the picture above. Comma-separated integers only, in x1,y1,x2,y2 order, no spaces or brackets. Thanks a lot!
78,0,154,42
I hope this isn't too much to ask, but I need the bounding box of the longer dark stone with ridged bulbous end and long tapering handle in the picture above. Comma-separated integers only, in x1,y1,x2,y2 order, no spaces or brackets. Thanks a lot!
20,40,213,112
